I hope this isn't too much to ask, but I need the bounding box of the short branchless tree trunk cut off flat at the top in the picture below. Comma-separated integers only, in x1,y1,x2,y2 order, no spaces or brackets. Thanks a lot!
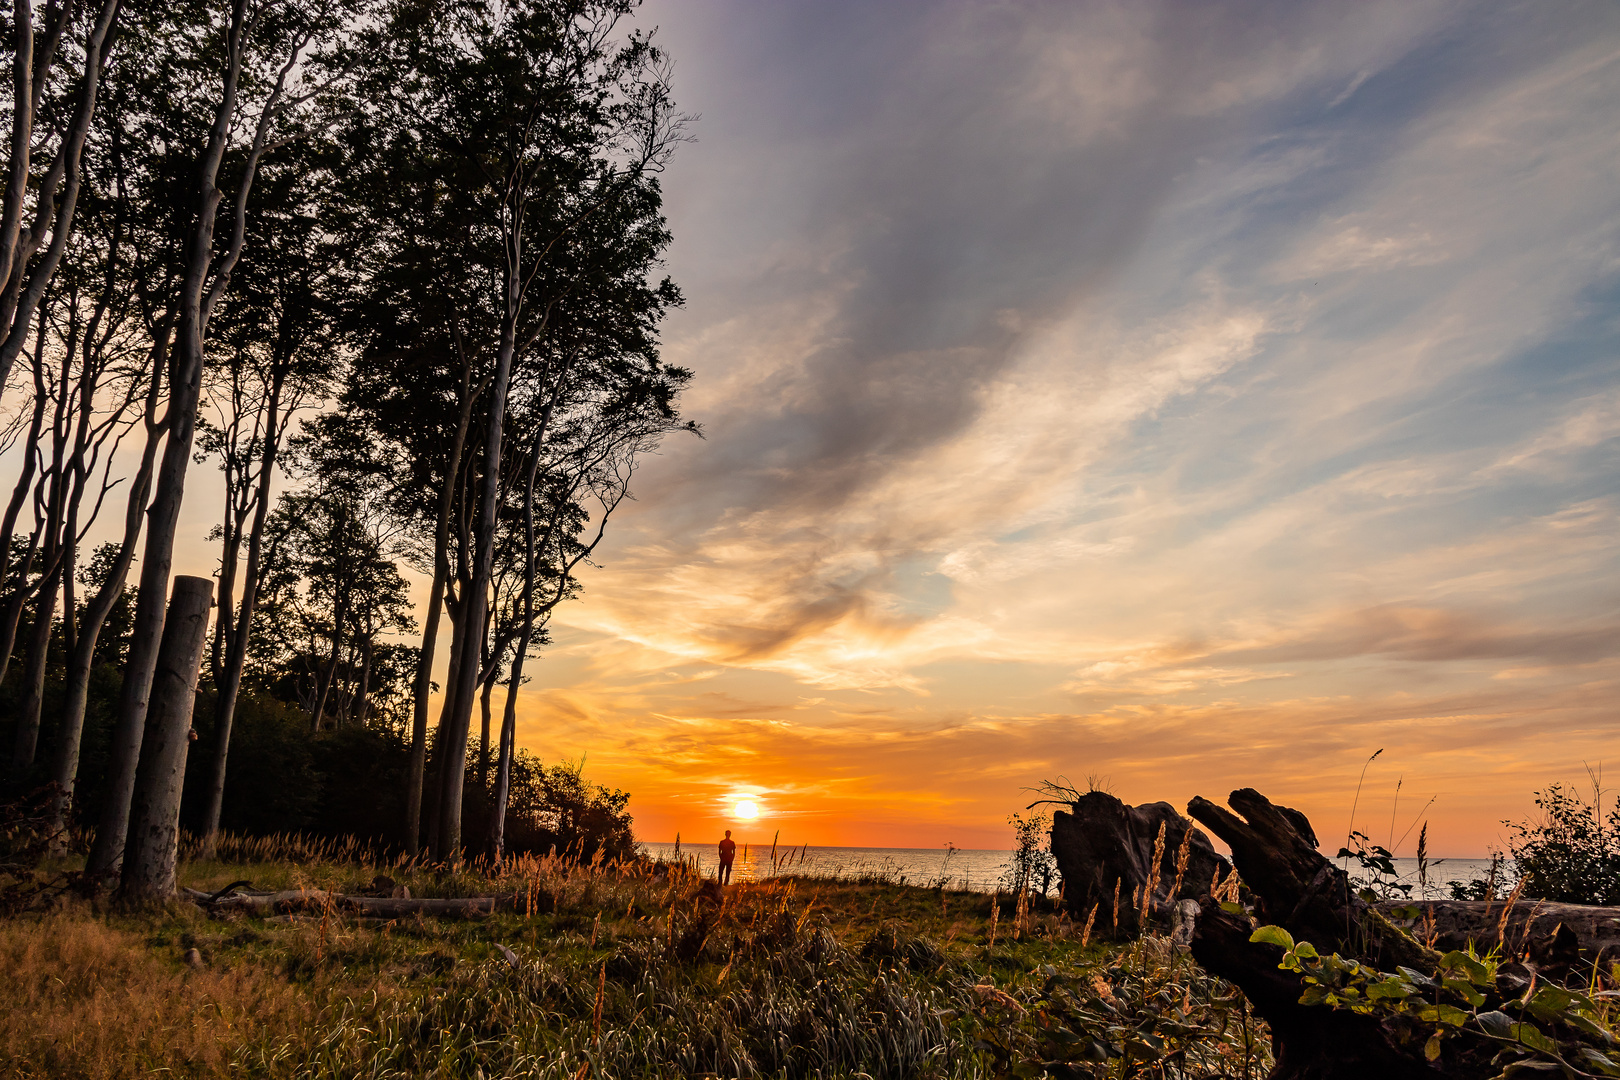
123,576,214,900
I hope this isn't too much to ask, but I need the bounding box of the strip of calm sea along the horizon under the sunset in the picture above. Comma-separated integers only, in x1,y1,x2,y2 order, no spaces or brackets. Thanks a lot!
640,842,1513,900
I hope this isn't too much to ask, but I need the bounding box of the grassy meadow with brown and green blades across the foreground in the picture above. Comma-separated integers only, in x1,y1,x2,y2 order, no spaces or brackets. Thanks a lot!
0,842,1270,1080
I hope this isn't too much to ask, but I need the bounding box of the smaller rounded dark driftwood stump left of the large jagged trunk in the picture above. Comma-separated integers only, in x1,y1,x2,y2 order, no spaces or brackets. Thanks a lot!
1051,792,1231,939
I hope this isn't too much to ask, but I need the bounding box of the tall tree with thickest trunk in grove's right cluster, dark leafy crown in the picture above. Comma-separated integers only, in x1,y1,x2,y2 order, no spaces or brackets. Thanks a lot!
350,0,682,855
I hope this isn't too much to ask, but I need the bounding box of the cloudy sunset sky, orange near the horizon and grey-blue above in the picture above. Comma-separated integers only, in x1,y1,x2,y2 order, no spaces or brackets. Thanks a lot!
129,0,1620,857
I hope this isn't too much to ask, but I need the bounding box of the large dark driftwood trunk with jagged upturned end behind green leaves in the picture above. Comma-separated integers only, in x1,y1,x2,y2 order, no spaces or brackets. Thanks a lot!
1187,789,1615,1080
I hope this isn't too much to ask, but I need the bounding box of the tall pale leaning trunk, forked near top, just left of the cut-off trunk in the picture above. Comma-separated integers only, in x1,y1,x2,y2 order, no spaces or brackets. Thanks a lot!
84,0,308,879
